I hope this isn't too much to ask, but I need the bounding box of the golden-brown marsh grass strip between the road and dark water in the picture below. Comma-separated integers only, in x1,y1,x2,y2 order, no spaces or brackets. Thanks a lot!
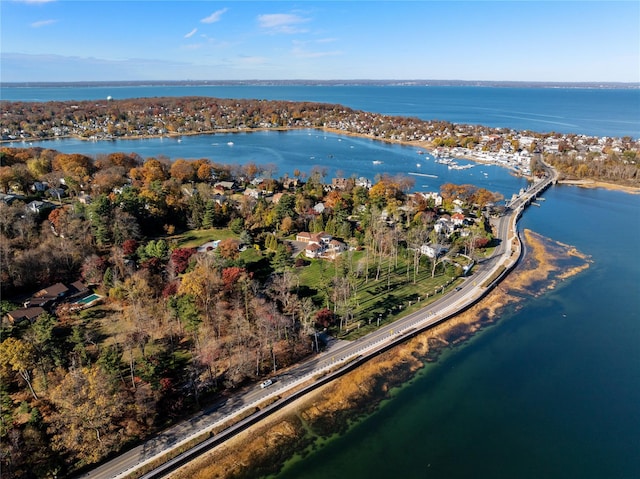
171,230,591,479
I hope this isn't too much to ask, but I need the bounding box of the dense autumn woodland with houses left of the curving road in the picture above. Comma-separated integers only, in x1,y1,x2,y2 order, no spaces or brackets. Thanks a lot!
0,142,500,478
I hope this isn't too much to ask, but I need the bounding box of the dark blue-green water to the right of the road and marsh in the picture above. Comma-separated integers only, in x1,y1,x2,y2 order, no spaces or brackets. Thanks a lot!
277,187,640,479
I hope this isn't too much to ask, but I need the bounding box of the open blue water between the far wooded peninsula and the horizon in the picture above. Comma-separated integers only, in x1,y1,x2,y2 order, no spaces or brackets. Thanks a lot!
0,85,640,138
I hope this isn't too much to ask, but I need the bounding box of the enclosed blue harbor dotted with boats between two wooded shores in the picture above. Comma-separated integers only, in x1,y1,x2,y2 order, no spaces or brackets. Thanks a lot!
22,130,527,198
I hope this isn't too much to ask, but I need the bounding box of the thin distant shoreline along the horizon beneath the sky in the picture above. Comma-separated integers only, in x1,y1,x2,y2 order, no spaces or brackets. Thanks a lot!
0,79,640,89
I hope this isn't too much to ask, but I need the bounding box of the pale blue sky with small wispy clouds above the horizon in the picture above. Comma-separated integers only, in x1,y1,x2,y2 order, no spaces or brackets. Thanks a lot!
0,0,640,82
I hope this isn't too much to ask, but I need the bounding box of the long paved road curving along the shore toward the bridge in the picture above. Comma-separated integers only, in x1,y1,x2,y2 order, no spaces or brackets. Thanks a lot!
81,162,556,479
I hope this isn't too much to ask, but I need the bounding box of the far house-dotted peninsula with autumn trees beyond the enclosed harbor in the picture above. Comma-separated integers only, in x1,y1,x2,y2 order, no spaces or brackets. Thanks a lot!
0,97,640,189
